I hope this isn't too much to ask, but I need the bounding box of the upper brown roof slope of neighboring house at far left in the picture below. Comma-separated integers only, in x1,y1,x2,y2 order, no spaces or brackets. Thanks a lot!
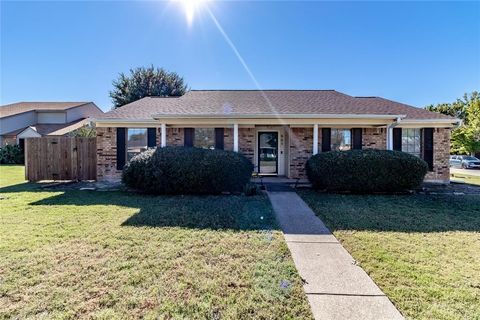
0,102,89,118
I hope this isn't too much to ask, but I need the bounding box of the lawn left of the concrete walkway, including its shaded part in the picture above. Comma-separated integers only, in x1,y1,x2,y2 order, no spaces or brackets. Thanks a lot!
0,166,311,319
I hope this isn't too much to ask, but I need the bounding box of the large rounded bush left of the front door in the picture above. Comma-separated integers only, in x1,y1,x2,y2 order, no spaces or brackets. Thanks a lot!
122,147,253,194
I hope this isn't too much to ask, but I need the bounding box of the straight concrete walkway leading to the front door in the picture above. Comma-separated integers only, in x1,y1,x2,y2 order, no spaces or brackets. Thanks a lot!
267,187,403,320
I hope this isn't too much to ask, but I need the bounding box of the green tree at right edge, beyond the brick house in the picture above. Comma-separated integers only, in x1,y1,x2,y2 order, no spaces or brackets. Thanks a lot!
426,91,480,155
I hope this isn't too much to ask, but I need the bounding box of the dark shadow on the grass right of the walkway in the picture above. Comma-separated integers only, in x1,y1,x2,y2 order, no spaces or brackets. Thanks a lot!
299,191,480,232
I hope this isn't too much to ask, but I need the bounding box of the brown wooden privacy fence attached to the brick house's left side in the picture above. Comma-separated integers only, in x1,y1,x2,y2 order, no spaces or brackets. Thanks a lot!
25,137,97,181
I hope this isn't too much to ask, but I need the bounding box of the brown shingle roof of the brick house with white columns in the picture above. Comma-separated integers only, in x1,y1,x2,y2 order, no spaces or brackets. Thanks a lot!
99,90,453,120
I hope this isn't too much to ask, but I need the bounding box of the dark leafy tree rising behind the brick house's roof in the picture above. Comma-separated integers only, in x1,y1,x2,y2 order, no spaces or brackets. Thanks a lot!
110,66,187,108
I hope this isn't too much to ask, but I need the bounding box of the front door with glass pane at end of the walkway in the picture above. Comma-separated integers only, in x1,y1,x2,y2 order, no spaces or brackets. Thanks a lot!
258,132,278,174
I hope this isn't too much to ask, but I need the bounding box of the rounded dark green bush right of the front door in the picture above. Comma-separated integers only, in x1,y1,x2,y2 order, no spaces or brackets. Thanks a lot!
306,150,428,193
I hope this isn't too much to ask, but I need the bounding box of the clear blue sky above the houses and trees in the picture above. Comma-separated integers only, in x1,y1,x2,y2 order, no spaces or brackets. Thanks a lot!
0,0,480,111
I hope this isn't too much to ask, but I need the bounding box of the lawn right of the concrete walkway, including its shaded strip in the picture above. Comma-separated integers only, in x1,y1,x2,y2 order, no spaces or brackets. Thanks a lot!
300,191,480,319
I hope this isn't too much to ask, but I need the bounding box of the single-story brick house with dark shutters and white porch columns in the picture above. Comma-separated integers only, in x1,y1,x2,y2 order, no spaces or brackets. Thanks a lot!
94,90,458,182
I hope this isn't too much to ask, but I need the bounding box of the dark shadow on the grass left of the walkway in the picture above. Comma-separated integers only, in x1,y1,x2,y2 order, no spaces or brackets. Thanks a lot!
30,191,277,230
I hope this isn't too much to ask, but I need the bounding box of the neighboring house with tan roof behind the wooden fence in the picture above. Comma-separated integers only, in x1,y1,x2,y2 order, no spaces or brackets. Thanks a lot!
0,102,103,146
